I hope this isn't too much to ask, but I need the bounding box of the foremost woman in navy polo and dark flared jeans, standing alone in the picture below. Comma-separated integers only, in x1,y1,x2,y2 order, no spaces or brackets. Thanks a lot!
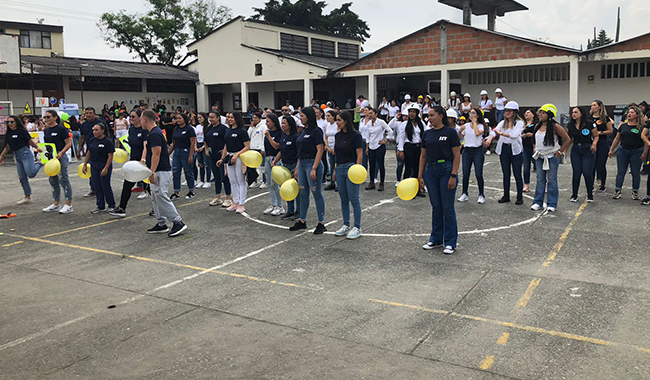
418,106,460,255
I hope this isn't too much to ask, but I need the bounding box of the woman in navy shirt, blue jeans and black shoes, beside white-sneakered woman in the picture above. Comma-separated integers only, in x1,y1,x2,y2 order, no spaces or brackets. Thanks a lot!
289,107,327,235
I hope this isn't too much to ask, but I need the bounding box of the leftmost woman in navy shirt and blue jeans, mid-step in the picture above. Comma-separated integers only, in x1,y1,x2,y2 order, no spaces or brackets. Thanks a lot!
0,115,43,205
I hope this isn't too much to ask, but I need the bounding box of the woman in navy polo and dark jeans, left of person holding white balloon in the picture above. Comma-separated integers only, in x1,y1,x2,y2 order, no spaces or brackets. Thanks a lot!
83,124,115,214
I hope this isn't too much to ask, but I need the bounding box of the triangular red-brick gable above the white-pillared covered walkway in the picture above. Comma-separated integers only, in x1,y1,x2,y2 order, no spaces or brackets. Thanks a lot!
343,22,571,71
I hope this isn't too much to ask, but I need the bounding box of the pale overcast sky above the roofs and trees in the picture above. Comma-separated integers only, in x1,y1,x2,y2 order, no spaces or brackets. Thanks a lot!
5,0,650,60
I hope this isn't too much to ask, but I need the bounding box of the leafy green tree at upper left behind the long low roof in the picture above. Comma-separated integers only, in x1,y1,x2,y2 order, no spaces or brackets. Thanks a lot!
97,0,232,65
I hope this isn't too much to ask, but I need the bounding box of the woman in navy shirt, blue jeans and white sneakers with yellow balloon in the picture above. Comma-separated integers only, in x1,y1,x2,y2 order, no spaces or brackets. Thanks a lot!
334,111,363,239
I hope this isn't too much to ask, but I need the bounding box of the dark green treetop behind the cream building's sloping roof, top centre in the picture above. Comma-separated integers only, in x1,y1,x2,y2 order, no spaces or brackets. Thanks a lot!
252,0,370,41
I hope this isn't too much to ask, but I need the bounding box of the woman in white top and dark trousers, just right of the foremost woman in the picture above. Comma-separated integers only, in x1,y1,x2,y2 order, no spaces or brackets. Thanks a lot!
458,109,489,204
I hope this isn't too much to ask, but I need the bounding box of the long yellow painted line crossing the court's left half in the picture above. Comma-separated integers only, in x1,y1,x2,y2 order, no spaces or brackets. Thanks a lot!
7,234,317,290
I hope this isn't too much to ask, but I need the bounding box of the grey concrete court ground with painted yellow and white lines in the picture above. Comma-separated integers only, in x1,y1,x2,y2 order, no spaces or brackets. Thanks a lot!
0,149,650,380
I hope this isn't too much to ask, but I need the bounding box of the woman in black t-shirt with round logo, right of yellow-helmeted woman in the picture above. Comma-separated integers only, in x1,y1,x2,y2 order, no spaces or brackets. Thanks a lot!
568,107,599,202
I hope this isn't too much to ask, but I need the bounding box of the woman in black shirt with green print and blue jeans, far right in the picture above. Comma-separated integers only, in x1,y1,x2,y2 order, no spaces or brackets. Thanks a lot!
609,106,650,200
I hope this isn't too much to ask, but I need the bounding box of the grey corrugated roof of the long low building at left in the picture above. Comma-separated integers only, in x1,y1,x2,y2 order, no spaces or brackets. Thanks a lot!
21,56,199,81
